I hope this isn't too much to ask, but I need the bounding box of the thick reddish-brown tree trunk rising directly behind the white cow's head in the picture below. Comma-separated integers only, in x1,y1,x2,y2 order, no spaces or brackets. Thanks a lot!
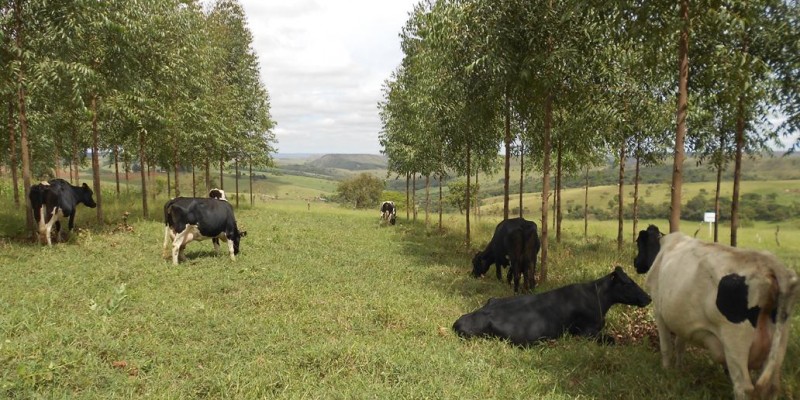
669,0,689,232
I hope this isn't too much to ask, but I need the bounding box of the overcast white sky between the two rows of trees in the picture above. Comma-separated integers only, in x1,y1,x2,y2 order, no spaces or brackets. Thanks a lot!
240,0,418,154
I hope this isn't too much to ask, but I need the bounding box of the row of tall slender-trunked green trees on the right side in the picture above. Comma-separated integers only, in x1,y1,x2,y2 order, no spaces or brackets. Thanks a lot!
379,0,800,279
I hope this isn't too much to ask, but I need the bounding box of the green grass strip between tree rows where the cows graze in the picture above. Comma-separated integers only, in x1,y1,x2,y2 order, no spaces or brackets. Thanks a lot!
0,202,800,399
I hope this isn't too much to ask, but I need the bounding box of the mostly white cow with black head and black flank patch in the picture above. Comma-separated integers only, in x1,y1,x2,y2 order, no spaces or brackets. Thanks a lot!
634,225,798,399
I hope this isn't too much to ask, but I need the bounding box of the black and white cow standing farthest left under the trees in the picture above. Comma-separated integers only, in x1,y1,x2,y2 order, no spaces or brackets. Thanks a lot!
28,178,97,246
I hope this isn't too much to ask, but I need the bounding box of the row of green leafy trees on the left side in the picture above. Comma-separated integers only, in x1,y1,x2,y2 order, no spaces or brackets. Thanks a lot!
0,0,275,227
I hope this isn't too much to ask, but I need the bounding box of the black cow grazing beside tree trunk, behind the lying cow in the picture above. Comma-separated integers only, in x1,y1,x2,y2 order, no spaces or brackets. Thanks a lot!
472,218,541,293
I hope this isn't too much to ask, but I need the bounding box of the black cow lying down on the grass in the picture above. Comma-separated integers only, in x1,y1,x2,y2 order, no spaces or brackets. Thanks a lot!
453,267,650,346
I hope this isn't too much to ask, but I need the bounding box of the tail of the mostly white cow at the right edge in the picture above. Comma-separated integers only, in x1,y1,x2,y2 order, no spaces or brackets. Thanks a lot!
755,268,800,397
